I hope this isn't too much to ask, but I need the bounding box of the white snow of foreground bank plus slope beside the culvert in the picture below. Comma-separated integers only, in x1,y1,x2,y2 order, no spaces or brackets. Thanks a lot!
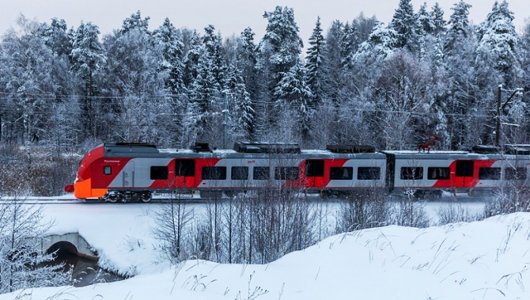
0,200,530,300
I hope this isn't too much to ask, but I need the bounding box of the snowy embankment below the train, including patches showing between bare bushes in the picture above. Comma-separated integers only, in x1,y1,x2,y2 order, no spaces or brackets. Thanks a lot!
36,199,484,275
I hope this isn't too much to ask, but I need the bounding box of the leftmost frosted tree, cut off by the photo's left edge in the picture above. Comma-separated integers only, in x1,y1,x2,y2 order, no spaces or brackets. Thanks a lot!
0,16,58,143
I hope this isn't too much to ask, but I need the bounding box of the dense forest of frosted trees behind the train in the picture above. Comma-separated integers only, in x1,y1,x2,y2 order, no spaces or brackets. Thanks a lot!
0,0,530,150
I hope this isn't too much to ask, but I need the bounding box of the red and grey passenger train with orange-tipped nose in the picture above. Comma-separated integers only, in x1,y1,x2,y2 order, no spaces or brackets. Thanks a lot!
65,142,530,202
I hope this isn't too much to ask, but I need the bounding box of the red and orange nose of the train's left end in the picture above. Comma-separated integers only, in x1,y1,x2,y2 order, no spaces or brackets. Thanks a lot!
64,145,108,199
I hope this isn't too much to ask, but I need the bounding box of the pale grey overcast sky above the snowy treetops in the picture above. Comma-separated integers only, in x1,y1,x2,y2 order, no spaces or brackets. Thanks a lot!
0,0,530,43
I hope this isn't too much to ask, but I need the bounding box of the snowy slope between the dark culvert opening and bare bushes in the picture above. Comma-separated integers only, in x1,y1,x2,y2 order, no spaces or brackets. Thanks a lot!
44,203,173,275
